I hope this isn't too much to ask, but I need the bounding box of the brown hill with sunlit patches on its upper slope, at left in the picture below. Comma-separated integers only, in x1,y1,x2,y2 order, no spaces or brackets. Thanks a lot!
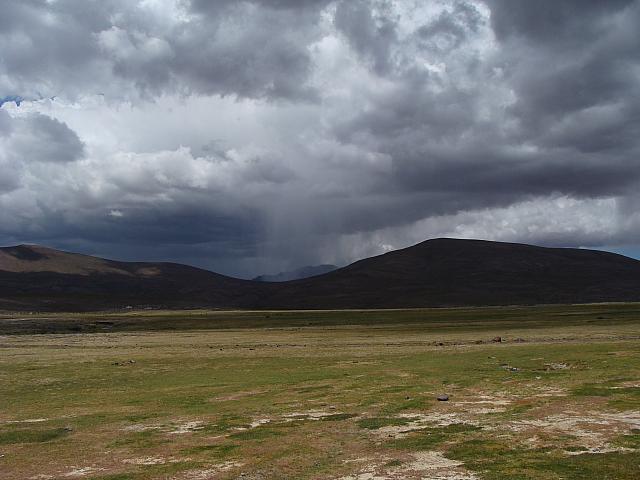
0,245,257,311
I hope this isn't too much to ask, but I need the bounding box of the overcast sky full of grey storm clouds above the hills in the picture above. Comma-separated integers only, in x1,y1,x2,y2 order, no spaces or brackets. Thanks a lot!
0,0,640,278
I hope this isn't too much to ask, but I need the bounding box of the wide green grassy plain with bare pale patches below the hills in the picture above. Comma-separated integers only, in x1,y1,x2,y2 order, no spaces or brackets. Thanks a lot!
0,304,640,480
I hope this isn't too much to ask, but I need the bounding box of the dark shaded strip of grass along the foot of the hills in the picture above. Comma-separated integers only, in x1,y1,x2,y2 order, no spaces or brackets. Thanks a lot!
0,303,640,334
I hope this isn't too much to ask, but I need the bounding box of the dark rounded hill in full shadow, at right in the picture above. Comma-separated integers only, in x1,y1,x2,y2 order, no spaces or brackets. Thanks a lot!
258,238,640,308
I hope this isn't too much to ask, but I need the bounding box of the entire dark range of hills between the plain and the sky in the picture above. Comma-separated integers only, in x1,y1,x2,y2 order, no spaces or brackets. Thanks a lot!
0,238,640,311
